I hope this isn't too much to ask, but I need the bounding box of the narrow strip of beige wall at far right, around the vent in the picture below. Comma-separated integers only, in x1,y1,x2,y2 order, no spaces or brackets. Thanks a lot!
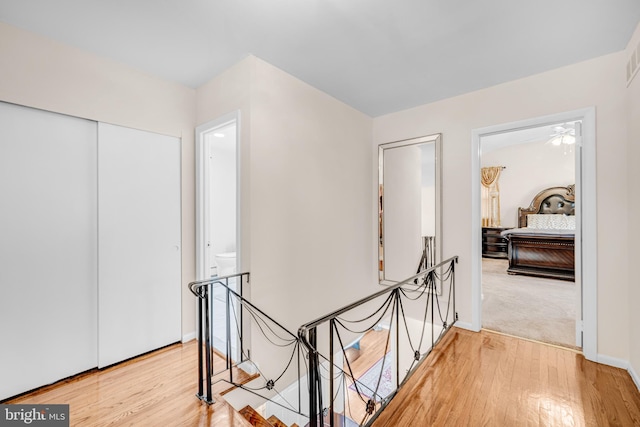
618,25,640,387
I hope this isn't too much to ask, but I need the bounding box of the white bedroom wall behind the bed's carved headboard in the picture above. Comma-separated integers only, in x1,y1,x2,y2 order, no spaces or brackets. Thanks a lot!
481,141,575,227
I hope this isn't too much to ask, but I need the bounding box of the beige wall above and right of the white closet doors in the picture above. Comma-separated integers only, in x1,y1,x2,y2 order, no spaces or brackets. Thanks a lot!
0,23,195,334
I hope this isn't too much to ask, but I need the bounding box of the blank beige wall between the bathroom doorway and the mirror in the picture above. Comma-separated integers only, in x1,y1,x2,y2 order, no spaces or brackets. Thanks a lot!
250,59,375,328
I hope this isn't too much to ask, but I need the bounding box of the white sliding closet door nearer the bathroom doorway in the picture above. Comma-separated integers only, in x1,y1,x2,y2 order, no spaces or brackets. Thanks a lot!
98,123,181,367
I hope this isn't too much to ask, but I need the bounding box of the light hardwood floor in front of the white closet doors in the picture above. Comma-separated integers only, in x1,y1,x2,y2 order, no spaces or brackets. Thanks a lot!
5,341,251,427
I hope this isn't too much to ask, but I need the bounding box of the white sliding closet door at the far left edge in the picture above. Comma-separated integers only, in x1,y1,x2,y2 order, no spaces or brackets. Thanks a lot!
0,103,97,400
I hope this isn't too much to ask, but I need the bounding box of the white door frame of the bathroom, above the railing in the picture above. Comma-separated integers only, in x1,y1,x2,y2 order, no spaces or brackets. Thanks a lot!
195,110,242,280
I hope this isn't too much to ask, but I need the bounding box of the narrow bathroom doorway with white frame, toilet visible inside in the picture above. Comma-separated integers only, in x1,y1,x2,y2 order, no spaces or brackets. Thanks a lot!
196,112,243,360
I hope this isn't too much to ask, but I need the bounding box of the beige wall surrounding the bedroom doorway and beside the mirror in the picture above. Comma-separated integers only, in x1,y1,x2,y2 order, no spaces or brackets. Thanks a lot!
373,53,629,360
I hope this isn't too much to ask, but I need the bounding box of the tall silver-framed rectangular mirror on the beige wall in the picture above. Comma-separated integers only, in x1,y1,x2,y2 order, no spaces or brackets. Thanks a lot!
378,134,442,285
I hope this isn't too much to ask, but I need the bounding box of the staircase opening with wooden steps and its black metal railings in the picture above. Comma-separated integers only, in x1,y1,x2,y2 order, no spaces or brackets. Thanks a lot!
189,256,458,427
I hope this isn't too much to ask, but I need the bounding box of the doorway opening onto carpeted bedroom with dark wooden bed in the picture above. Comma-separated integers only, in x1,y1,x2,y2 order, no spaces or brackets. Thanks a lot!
480,121,582,348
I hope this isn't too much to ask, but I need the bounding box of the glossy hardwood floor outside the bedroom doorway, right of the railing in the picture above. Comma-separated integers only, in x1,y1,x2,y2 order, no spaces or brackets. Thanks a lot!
373,328,640,427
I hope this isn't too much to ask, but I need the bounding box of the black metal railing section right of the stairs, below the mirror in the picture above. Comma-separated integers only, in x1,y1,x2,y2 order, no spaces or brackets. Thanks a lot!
298,256,458,427
